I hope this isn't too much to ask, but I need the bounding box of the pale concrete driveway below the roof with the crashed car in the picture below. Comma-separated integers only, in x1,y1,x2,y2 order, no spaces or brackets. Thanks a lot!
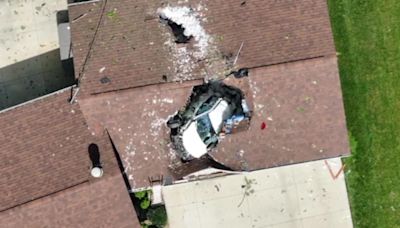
163,159,352,228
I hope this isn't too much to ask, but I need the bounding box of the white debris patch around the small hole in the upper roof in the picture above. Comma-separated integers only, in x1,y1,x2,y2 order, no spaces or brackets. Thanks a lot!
157,4,233,82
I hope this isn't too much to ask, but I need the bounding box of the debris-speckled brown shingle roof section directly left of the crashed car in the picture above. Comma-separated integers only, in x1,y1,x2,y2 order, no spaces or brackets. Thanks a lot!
79,80,202,189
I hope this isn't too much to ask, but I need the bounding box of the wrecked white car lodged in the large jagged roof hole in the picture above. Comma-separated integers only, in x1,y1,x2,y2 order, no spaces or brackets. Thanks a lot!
167,82,250,161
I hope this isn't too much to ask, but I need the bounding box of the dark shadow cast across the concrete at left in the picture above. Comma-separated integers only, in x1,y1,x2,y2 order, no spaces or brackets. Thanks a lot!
0,49,75,110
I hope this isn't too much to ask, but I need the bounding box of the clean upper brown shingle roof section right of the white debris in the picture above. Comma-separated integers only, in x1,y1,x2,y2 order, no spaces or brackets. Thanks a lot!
205,0,335,68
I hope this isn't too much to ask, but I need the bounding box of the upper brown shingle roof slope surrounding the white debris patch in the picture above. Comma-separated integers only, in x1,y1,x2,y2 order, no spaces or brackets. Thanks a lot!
69,0,335,94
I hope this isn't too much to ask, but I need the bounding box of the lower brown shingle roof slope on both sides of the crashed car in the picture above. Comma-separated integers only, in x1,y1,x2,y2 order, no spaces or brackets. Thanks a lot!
76,56,349,188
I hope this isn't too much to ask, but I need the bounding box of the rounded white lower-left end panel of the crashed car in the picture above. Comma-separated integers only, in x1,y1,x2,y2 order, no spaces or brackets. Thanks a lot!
182,121,207,158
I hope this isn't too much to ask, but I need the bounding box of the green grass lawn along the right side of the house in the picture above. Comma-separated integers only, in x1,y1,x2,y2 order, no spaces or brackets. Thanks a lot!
328,0,400,228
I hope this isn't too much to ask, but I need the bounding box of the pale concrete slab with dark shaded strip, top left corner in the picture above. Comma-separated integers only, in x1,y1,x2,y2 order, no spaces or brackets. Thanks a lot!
0,0,73,109
